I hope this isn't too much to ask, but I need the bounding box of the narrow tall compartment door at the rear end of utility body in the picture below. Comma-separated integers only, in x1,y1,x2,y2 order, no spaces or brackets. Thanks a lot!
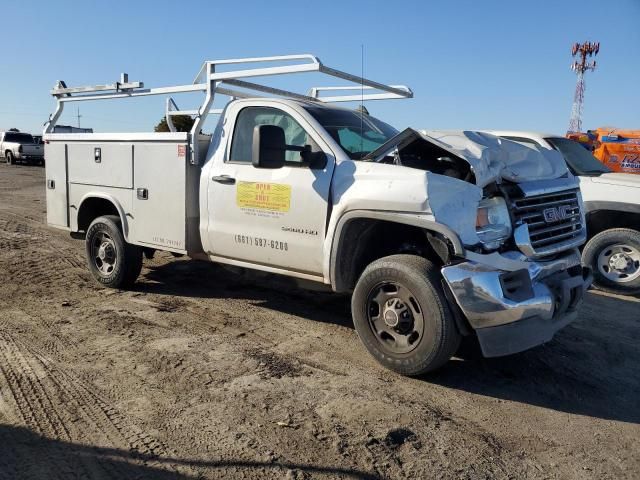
45,142,69,228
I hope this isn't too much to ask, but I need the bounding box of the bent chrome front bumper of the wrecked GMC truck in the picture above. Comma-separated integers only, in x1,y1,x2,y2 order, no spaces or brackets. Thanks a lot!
442,250,592,357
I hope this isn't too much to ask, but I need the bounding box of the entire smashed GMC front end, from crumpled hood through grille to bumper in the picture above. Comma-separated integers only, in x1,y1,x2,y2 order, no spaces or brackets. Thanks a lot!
368,129,591,356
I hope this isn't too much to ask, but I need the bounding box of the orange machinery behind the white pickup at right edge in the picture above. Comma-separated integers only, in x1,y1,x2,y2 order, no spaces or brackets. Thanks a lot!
567,127,640,174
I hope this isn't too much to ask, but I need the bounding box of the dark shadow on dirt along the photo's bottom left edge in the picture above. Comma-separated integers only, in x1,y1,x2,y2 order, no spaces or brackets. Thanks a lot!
0,425,380,480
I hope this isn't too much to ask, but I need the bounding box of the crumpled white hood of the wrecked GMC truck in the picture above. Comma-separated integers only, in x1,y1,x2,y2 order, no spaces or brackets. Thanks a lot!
368,128,568,187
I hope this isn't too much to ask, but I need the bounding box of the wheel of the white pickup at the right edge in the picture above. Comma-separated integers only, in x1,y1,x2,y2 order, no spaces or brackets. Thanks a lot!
582,228,640,295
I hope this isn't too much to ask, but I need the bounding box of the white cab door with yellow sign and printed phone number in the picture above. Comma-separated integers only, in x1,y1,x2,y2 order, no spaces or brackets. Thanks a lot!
208,106,335,276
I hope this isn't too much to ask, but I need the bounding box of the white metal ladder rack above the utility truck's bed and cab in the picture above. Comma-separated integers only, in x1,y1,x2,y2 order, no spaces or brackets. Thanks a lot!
44,54,413,163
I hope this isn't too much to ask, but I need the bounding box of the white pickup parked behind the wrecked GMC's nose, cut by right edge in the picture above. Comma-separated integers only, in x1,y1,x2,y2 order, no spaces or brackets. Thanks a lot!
491,131,640,294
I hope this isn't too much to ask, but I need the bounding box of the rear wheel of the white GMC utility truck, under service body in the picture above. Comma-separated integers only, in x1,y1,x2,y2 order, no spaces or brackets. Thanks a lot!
85,215,142,288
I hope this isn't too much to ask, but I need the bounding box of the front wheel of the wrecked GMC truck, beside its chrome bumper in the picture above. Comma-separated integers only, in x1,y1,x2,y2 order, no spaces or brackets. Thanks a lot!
351,255,460,376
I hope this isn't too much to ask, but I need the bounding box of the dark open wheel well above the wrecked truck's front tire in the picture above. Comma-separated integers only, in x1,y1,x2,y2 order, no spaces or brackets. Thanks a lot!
333,218,450,292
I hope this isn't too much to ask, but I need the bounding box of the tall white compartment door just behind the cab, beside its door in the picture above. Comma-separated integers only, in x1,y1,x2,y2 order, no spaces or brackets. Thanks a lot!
129,140,188,252
